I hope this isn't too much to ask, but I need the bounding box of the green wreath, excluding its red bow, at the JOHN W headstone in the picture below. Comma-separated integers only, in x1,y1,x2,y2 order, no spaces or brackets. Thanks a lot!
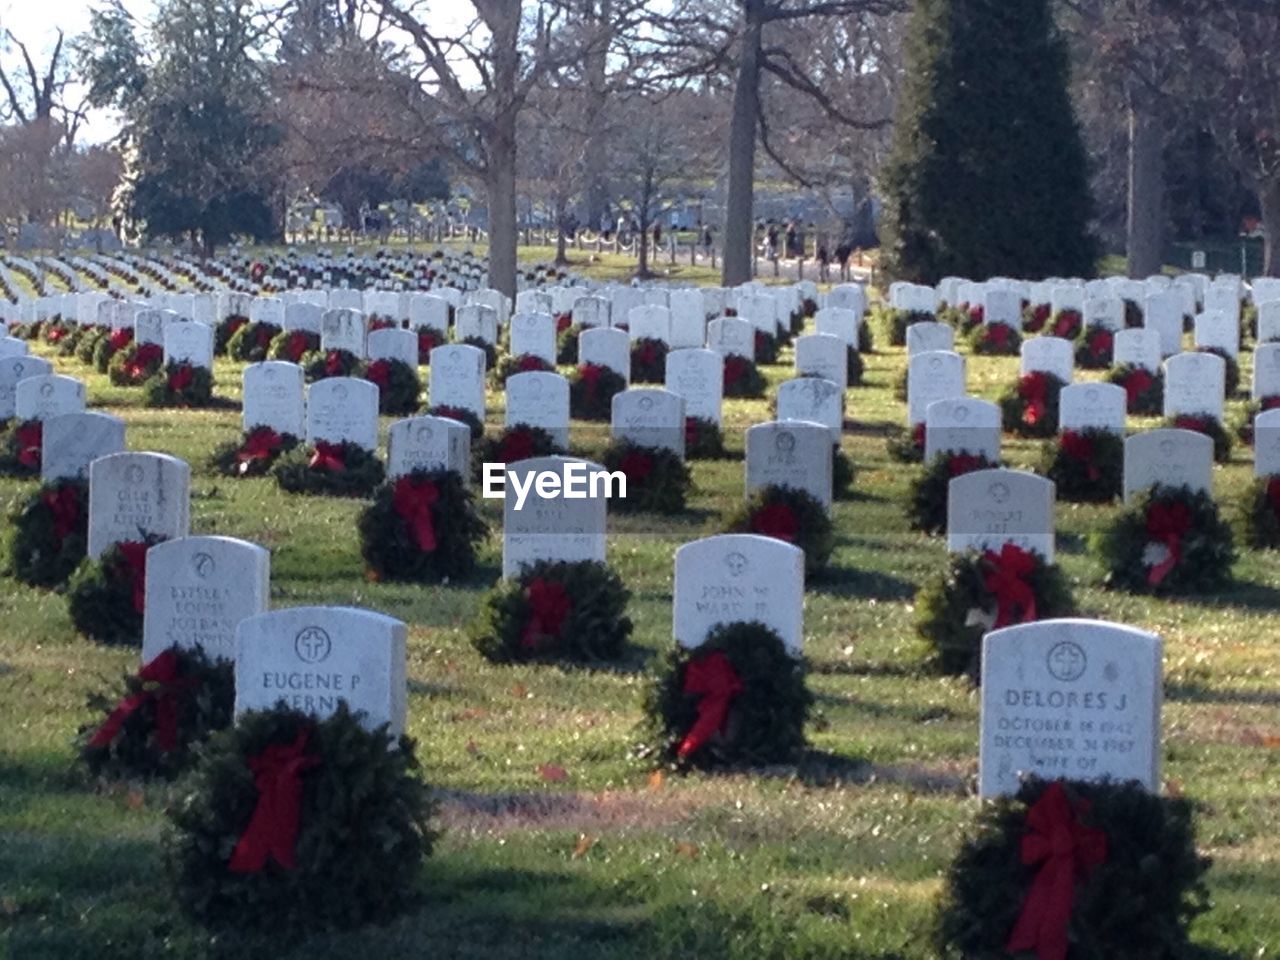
640,621,813,769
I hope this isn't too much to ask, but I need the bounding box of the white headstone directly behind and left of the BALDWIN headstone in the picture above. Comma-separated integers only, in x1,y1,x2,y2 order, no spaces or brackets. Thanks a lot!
88,453,191,559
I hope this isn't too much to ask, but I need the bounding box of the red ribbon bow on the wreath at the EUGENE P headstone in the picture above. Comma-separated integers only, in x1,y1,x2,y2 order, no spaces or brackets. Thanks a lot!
228,728,320,873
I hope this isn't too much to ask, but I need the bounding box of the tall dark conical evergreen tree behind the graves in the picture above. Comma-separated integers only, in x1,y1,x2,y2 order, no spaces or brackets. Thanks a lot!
882,0,1097,283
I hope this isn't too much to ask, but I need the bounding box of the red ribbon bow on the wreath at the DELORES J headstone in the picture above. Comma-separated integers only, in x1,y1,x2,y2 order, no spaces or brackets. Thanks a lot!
1005,781,1107,960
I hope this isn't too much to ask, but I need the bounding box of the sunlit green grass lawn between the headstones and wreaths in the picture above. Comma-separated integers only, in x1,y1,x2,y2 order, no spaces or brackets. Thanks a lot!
0,320,1280,960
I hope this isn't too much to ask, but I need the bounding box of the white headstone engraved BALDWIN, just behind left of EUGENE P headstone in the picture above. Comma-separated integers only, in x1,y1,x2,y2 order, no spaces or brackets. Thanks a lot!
142,536,271,663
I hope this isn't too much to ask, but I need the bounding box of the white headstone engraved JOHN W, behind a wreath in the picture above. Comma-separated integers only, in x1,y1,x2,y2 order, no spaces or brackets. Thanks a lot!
672,534,804,655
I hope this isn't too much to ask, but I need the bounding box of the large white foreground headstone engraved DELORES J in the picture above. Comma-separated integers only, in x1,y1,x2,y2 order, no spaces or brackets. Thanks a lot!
978,620,1164,797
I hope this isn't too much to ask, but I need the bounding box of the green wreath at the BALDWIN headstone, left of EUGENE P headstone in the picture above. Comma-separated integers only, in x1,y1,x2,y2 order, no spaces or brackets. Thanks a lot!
76,648,236,780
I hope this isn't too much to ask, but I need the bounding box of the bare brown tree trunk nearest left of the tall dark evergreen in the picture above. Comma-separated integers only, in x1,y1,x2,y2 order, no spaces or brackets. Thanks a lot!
721,0,764,287
